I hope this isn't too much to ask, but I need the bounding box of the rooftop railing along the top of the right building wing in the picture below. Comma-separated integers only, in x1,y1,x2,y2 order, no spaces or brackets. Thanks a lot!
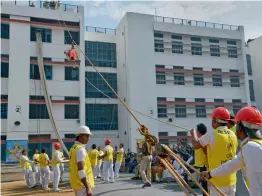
155,16,239,31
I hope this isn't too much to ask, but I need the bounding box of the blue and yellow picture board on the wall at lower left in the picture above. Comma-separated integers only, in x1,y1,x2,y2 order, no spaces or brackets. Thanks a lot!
6,140,28,163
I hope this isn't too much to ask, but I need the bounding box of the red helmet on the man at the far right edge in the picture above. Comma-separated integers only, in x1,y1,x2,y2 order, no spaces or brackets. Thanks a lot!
235,106,262,126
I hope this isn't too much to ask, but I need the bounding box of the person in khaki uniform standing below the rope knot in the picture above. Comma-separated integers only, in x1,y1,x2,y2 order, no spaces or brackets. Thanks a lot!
140,139,152,188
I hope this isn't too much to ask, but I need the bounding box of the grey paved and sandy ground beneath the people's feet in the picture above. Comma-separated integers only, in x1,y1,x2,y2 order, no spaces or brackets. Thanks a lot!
1,171,249,196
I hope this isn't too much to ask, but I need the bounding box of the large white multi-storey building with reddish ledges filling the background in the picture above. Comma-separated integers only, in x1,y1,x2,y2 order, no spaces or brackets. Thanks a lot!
1,5,253,159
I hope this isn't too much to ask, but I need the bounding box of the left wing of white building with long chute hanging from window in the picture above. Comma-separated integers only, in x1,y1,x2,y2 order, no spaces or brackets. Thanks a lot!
1,2,85,160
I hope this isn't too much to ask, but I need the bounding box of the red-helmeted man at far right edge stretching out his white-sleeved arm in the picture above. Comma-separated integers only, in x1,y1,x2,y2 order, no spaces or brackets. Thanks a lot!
201,106,262,196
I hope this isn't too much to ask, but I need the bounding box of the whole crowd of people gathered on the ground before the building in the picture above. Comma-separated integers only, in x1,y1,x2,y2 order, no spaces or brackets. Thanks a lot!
19,107,262,196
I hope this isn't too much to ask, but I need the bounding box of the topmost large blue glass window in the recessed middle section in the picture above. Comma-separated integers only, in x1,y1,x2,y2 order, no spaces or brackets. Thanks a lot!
85,41,117,67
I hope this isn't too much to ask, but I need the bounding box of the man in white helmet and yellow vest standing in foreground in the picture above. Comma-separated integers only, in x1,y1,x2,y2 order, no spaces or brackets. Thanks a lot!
69,125,95,196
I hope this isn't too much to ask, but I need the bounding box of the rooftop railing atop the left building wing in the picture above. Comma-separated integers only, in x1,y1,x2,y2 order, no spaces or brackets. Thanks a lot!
1,0,78,13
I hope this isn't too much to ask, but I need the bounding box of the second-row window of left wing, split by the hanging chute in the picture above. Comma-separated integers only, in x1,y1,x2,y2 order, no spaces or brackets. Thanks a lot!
30,64,53,80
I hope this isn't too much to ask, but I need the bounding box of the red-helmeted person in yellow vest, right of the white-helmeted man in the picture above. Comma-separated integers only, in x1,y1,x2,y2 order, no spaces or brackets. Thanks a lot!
99,139,115,183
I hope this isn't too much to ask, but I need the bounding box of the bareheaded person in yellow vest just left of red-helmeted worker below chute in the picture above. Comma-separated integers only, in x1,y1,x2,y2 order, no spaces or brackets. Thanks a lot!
39,148,50,190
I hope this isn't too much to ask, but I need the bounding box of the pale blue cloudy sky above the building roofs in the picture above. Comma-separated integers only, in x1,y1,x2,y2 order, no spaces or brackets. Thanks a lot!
71,0,262,40
